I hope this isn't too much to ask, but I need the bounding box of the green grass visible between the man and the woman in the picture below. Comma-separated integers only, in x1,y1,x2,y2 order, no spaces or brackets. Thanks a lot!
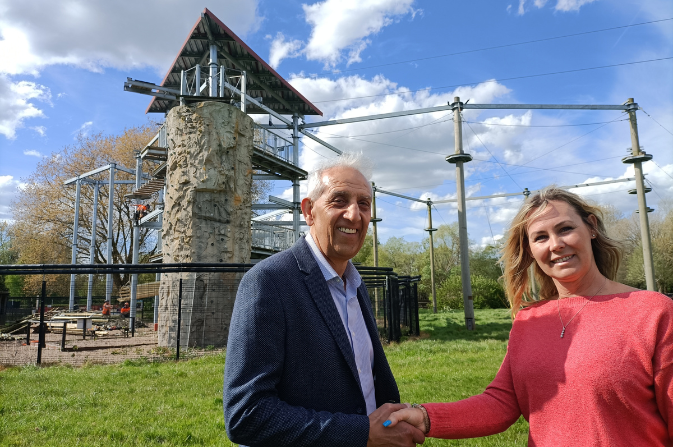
386,309,528,447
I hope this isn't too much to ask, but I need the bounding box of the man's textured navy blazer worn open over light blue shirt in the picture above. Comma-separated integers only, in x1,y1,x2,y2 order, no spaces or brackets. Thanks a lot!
223,238,400,447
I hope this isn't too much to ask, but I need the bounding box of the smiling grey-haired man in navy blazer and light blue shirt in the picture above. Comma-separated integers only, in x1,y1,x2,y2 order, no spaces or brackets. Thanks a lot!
224,154,424,447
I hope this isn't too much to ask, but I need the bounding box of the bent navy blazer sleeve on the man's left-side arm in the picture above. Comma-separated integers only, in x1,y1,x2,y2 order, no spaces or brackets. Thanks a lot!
223,269,369,447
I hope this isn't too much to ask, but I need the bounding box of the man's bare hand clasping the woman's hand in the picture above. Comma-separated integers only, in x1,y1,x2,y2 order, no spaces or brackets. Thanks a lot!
367,404,425,447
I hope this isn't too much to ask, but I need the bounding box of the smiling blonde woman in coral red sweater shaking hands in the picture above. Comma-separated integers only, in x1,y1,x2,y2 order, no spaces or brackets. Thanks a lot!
384,187,673,446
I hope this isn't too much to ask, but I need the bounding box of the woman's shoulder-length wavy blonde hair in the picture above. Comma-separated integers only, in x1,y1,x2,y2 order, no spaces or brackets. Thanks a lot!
501,186,622,317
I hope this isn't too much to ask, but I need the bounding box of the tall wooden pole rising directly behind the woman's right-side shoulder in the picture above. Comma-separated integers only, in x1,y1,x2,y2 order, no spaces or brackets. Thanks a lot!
622,98,656,290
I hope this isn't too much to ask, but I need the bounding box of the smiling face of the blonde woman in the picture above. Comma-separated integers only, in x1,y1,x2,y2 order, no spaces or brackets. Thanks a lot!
528,200,596,282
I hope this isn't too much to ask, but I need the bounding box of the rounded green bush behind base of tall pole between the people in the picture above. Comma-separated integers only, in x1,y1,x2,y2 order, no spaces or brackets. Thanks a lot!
437,275,509,309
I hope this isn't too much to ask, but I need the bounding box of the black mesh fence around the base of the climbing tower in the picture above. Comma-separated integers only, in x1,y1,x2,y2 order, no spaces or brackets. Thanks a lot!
0,264,420,365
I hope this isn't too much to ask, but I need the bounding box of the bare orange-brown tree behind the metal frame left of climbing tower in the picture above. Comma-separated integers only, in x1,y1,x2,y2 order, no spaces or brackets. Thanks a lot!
12,123,269,294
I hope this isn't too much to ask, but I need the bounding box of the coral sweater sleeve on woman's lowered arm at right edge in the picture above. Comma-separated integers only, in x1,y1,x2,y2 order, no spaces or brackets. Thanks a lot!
652,303,673,439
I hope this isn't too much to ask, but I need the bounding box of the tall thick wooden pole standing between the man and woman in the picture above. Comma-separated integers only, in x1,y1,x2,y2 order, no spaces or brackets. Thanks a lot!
446,96,474,331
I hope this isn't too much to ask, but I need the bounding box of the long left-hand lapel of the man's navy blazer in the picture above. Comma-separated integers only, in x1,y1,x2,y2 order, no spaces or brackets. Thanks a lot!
292,238,362,389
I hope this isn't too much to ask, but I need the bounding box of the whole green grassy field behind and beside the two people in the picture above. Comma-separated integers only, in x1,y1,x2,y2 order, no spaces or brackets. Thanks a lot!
0,310,528,447
